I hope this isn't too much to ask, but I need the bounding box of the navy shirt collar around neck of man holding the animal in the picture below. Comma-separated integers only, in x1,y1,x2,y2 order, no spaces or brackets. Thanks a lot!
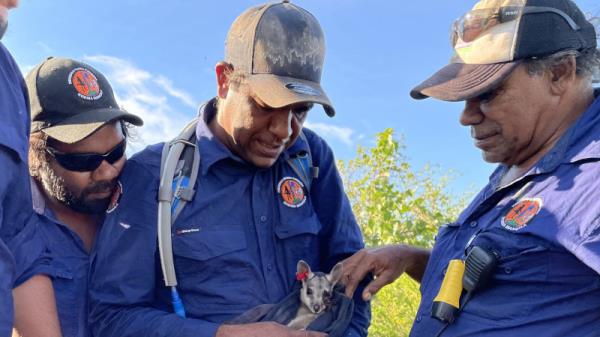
196,98,309,175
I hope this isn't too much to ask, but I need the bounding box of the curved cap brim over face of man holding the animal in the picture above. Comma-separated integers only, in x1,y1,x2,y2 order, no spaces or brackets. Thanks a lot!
248,74,335,117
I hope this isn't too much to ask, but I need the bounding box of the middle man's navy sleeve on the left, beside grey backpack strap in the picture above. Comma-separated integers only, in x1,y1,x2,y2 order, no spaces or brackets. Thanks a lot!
89,156,219,337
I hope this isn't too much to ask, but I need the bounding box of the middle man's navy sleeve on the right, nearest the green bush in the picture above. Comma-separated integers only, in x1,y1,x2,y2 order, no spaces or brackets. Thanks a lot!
305,129,371,337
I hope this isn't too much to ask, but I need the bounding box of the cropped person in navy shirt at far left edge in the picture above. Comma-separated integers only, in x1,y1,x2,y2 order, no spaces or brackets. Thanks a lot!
0,0,60,337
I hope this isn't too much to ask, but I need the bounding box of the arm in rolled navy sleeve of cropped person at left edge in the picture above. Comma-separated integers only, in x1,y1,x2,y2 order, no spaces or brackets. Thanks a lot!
0,145,61,337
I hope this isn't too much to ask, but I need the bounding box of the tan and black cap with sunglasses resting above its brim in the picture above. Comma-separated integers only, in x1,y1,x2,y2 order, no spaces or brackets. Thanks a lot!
410,0,596,101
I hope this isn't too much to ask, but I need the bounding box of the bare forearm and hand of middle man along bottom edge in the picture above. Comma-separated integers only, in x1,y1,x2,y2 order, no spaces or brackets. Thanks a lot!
215,322,327,337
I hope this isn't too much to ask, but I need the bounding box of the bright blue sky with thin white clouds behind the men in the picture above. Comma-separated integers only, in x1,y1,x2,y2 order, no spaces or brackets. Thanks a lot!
3,0,600,192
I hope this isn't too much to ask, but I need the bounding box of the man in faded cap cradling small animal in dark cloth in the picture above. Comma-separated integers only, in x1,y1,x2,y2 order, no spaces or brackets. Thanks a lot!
90,1,370,337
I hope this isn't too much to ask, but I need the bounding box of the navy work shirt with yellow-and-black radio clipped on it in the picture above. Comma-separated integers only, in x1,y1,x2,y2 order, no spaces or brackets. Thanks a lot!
410,92,600,337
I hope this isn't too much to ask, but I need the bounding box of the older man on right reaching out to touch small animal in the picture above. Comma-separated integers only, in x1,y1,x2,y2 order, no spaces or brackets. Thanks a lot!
344,0,600,336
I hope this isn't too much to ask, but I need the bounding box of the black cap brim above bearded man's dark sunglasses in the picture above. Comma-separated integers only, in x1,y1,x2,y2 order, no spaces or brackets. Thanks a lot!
40,109,144,144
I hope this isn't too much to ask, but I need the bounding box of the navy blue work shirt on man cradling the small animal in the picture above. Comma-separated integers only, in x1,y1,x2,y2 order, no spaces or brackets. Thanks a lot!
90,100,370,337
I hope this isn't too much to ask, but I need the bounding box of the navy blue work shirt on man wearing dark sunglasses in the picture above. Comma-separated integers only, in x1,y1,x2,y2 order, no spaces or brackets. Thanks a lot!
31,180,90,337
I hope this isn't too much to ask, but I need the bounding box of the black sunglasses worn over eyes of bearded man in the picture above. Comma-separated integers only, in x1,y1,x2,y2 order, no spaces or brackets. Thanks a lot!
46,139,127,172
